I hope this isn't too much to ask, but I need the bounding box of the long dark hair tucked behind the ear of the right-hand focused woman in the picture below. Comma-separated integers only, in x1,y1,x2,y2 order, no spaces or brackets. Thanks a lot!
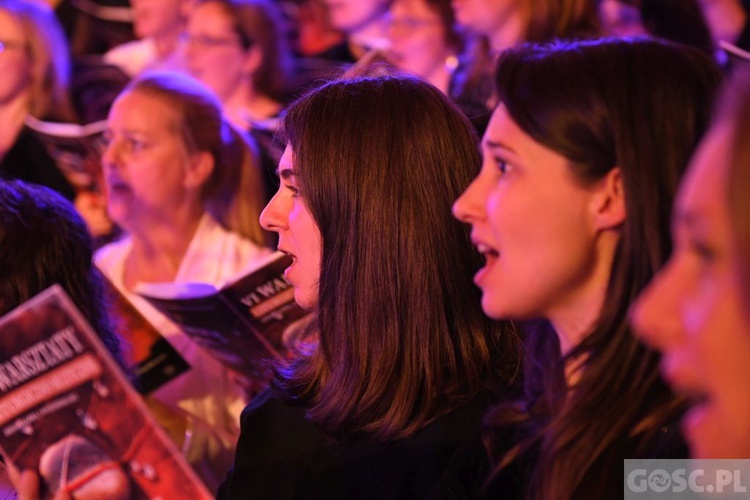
486,39,720,499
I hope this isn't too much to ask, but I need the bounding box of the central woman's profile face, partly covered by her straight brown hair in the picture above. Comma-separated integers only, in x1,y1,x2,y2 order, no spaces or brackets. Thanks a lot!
260,146,322,310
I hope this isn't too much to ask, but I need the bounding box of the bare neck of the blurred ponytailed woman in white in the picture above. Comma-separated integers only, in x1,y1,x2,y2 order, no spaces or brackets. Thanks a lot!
123,206,202,290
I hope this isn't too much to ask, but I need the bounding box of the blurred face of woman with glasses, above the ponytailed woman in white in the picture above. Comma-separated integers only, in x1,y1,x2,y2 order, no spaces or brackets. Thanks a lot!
185,2,250,101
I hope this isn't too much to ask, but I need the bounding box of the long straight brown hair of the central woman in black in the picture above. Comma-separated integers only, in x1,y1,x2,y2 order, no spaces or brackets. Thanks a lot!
276,76,518,440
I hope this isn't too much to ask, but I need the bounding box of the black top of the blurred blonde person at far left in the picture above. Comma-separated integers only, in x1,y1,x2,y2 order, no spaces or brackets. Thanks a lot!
0,126,75,200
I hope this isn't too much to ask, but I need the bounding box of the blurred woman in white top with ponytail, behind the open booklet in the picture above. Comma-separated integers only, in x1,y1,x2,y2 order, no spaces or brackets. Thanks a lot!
96,73,269,489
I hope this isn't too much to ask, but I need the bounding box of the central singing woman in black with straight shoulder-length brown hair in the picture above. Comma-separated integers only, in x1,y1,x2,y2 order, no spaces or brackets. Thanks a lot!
220,77,518,498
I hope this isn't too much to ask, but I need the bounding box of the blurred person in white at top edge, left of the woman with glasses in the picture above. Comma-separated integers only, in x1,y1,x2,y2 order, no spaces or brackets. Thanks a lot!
104,0,194,76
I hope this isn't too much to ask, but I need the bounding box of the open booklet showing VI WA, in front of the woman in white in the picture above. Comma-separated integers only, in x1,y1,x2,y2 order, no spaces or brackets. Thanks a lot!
135,252,306,379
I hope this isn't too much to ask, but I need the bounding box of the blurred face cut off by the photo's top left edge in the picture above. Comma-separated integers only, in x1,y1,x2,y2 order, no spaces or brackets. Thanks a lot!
0,9,31,105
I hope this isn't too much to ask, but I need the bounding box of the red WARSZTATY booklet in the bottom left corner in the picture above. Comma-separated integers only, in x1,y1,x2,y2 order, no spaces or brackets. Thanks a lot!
0,285,212,499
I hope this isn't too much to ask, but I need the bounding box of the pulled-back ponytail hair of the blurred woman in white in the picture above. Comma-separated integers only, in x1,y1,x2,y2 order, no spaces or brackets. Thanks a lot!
123,72,269,245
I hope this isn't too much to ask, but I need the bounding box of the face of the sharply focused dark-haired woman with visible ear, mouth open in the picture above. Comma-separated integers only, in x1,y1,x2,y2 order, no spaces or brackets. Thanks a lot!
453,104,607,330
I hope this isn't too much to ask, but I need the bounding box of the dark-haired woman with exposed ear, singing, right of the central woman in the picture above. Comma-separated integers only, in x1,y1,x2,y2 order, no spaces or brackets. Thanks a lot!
454,39,720,499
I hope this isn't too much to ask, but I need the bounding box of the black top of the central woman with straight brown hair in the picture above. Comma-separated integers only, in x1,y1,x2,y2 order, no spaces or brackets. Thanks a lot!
218,393,500,499
